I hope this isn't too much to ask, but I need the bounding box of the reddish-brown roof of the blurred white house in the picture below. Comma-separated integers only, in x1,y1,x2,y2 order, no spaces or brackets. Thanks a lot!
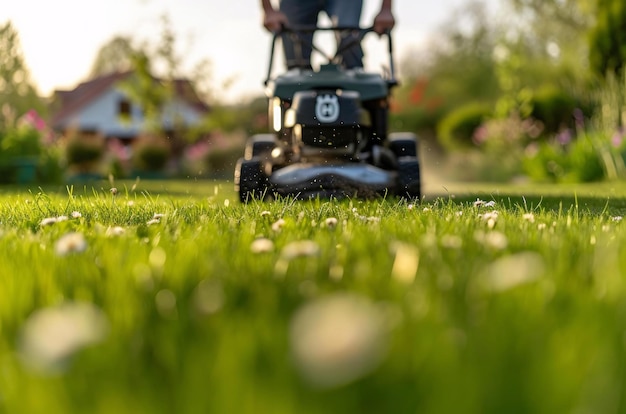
52,71,209,126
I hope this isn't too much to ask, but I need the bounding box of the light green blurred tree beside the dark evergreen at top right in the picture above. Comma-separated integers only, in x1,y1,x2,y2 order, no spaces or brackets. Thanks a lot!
488,0,592,118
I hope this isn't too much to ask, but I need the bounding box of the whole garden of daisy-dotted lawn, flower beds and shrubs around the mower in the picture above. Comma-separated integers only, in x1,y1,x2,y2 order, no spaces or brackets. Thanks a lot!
0,0,626,414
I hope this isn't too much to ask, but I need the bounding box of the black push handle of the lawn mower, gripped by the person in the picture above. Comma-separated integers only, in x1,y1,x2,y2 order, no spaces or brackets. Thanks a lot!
264,26,397,85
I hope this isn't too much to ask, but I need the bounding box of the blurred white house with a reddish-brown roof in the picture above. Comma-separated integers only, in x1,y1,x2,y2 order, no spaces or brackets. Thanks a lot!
51,71,209,143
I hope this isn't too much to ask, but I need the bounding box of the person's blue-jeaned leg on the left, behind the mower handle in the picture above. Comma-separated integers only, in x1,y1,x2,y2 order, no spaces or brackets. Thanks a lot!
280,0,323,69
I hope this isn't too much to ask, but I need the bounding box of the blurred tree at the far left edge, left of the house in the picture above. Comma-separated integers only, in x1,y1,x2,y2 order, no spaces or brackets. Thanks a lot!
0,21,45,130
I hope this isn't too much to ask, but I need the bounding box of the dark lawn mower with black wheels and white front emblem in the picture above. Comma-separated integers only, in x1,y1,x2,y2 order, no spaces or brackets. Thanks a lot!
234,27,421,203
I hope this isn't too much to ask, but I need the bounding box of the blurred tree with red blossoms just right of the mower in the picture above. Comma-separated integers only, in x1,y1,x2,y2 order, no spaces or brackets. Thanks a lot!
391,2,500,136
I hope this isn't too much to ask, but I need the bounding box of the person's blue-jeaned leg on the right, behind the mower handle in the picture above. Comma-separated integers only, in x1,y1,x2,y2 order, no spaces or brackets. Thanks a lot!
325,0,363,69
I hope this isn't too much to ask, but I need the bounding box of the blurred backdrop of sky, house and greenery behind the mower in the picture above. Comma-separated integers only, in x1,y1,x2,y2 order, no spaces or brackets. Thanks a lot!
0,0,626,182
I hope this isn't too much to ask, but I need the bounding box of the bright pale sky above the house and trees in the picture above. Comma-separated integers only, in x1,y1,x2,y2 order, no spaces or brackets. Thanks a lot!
0,0,497,99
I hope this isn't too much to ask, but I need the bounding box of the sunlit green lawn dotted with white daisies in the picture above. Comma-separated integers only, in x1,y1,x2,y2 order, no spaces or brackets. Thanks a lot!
0,182,626,413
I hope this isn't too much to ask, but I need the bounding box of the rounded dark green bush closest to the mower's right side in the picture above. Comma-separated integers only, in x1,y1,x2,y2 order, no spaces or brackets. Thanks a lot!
437,102,492,150
